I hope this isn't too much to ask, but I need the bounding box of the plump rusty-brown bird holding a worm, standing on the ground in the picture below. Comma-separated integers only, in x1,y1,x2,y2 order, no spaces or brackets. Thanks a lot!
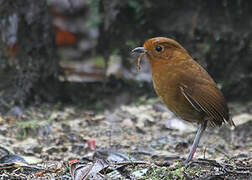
132,37,234,163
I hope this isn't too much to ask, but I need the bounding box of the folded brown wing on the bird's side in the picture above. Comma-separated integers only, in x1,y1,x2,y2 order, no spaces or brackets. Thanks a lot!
179,60,234,126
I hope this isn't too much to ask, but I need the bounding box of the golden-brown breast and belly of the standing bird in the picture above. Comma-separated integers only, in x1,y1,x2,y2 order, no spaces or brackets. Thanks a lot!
152,61,201,122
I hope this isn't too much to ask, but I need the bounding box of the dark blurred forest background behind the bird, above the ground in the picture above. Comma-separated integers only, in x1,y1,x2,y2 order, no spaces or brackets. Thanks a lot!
0,0,252,108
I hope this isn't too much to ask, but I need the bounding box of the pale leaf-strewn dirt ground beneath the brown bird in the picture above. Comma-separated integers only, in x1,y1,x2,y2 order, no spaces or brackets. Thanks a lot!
0,98,252,179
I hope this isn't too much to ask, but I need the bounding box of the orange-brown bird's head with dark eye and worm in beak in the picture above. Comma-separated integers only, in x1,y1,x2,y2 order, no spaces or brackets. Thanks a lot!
132,37,190,69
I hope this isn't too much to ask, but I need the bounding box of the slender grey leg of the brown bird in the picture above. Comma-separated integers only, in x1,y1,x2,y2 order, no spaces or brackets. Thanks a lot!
182,121,207,164
